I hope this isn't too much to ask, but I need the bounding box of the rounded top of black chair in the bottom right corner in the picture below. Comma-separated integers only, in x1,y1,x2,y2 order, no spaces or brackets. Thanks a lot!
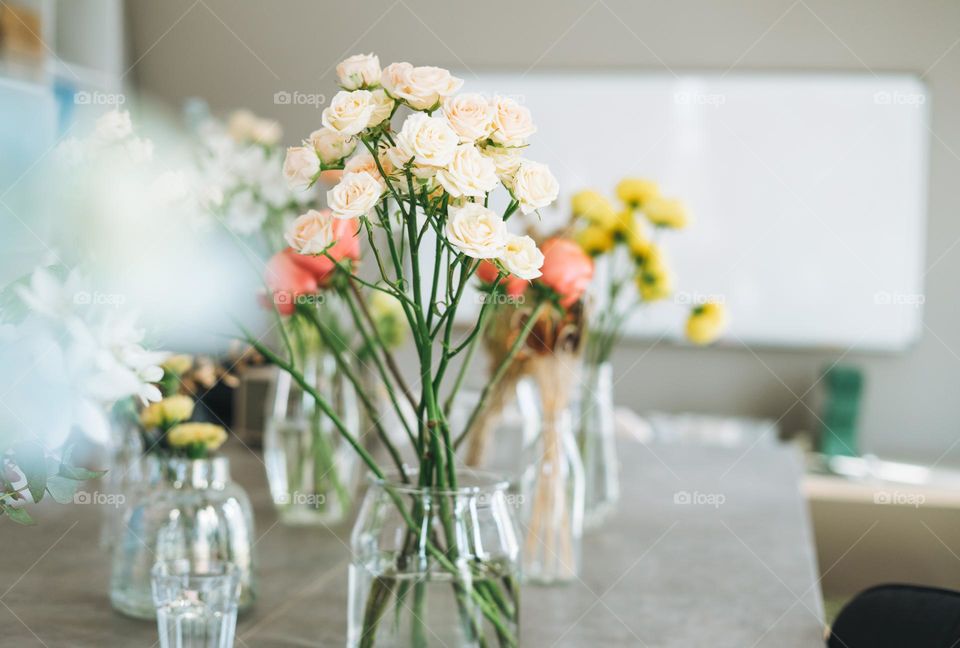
827,585,960,648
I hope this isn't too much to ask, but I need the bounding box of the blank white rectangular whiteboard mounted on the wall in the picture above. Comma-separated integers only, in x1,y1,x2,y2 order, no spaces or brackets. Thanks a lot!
462,73,930,351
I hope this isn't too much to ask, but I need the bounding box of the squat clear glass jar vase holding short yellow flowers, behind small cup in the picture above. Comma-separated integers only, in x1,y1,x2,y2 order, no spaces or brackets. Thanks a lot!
110,455,256,619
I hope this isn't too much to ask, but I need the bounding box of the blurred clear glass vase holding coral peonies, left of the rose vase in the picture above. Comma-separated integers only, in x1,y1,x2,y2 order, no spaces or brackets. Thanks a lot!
263,354,362,526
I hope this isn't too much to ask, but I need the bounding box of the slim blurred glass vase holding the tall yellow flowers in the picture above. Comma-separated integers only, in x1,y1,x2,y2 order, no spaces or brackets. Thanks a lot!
577,362,620,529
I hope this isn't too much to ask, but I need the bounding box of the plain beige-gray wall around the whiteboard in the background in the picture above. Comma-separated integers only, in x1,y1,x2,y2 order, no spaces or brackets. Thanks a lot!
128,0,960,464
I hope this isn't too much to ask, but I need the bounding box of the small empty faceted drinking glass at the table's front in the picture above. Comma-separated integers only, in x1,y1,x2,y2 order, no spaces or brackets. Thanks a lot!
151,559,240,648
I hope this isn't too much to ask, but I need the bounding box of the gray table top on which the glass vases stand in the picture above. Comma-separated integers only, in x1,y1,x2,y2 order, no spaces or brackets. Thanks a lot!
0,442,824,648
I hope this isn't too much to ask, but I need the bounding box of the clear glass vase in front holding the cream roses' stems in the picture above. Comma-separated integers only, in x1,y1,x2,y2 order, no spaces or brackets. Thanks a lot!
347,470,520,648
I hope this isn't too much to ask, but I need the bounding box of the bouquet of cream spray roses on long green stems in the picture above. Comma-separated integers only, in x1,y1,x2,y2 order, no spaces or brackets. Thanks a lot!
247,55,558,646
